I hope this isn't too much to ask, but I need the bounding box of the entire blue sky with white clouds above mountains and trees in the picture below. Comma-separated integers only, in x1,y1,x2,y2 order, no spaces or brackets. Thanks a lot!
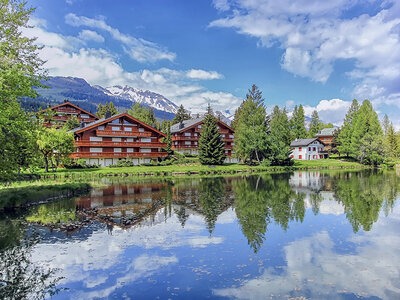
24,0,400,129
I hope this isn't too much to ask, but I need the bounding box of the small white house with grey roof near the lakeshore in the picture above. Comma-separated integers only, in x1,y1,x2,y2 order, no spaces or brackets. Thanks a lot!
290,138,328,160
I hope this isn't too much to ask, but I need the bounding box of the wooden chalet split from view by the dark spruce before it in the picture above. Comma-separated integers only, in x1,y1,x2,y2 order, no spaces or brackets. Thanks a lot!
171,118,235,160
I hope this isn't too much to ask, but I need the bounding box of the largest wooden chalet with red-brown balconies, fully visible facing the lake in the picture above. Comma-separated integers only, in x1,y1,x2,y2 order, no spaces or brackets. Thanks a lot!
70,113,167,166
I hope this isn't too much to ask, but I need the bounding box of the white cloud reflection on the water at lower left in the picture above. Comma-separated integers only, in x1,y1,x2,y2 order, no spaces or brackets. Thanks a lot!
32,211,224,298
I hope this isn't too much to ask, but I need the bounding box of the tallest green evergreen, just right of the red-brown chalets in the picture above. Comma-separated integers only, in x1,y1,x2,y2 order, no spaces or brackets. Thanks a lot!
234,85,271,163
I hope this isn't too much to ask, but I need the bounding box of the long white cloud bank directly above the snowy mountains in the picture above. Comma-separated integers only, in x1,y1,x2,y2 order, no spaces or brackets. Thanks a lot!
26,15,241,113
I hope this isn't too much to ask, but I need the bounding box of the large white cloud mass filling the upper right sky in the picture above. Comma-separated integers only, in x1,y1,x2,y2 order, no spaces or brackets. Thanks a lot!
210,0,400,117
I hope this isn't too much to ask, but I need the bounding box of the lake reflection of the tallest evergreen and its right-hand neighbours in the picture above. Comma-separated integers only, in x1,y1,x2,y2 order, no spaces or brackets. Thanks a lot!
233,174,305,252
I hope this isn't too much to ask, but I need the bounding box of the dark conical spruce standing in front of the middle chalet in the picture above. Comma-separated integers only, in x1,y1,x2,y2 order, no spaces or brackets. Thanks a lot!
199,107,225,165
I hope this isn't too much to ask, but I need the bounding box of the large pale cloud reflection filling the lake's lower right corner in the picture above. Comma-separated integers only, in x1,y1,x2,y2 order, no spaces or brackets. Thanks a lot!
214,206,400,299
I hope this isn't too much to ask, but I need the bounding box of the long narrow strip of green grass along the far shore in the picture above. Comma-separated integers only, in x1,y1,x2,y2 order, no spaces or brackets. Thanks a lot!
29,159,367,178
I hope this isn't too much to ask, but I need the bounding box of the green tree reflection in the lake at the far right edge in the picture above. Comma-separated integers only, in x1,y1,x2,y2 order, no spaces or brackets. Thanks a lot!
335,171,400,232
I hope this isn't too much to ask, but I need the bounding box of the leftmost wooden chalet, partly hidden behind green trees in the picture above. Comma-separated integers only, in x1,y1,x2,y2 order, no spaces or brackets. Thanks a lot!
38,100,99,127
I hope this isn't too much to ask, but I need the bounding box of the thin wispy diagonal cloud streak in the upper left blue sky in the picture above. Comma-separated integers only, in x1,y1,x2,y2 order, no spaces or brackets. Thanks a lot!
65,13,176,63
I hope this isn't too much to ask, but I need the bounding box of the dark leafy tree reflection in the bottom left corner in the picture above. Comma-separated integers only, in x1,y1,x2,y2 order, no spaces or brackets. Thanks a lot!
0,239,61,299
